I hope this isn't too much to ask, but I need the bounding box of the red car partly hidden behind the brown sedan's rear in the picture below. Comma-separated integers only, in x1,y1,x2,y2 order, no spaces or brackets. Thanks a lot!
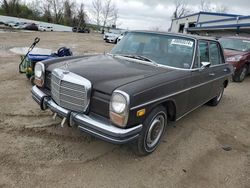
219,37,250,82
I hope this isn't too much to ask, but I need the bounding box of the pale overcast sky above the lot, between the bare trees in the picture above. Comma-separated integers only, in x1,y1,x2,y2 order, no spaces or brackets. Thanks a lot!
78,0,250,30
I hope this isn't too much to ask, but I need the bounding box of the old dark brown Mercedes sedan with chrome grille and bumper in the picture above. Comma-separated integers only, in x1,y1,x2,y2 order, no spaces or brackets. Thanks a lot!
32,31,232,155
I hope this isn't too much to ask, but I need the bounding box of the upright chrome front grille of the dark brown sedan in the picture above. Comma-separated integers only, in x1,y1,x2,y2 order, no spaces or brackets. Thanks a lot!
51,69,91,112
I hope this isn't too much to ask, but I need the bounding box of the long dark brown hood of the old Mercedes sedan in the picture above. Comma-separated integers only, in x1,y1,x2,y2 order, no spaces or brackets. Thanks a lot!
47,55,172,94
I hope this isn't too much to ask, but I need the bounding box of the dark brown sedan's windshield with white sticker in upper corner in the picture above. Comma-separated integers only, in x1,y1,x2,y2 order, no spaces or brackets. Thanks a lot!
111,32,195,69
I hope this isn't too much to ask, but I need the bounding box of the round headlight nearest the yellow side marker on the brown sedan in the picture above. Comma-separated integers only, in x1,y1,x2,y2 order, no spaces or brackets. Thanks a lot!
111,93,127,114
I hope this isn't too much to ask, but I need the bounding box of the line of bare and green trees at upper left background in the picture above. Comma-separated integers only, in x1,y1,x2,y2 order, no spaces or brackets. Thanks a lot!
0,0,118,29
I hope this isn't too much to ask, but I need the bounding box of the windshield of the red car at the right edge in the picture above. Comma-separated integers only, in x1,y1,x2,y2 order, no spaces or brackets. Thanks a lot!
219,38,250,52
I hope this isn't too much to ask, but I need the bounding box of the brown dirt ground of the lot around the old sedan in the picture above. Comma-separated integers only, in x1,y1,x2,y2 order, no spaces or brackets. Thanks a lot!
0,32,250,188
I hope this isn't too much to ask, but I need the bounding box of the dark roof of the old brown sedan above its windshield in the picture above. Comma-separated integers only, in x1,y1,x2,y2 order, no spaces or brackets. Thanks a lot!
128,30,217,42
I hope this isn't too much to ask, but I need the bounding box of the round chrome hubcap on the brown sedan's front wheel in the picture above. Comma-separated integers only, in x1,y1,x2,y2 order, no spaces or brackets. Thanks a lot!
146,115,165,148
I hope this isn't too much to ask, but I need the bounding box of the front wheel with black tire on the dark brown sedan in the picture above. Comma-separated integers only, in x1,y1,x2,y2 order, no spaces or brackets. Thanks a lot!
134,106,167,156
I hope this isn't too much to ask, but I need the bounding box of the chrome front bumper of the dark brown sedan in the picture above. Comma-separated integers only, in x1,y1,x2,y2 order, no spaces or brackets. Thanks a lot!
31,86,142,144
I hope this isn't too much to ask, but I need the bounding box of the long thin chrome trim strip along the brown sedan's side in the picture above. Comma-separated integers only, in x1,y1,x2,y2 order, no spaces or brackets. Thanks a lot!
130,74,231,110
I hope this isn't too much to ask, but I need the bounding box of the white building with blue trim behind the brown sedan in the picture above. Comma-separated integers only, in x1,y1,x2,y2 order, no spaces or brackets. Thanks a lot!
170,12,250,36
